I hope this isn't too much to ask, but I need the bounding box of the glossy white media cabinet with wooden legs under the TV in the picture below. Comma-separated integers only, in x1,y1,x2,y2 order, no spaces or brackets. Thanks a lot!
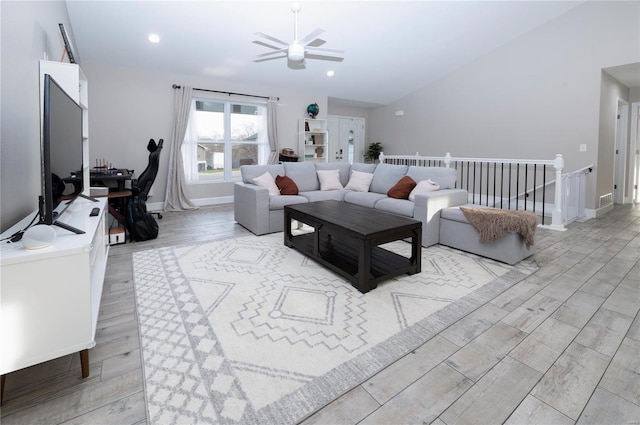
0,198,109,380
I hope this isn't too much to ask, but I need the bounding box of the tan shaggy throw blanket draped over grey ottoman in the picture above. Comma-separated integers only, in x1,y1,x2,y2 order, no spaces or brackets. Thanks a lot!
460,207,538,248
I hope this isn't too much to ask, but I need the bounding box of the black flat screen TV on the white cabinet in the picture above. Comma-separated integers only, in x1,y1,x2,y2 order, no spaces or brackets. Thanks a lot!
39,74,84,233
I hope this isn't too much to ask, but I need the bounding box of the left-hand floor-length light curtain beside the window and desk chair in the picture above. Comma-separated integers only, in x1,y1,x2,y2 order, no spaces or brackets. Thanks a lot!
164,86,198,211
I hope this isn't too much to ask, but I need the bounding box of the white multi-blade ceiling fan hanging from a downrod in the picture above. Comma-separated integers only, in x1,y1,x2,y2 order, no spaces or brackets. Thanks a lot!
254,3,344,68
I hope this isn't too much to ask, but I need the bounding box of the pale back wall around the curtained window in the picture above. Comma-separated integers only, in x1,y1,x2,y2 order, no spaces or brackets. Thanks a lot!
82,63,327,203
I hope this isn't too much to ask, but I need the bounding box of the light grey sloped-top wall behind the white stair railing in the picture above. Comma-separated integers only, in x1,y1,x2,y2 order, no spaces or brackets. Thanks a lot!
367,2,640,208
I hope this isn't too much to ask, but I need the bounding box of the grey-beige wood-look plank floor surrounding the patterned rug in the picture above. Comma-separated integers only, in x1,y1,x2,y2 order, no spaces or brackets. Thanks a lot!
1,205,640,425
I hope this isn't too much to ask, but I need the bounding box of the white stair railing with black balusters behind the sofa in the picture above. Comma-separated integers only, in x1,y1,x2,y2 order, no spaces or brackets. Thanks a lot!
379,152,593,230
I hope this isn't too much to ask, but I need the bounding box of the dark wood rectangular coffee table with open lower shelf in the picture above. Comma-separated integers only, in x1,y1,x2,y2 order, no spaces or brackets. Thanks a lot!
284,201,422,293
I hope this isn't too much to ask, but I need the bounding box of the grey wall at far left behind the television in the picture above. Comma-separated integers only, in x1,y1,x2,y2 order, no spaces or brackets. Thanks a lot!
0,1,75,231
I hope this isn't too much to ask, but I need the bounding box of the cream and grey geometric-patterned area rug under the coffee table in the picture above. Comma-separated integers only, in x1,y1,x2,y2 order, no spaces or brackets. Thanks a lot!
133,233,537,425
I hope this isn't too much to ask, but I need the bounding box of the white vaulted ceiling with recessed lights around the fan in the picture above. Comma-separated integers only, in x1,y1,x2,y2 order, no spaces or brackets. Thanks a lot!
67,0,580,106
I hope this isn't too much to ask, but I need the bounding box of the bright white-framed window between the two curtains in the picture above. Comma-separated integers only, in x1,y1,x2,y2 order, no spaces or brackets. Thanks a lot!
182,98,270,182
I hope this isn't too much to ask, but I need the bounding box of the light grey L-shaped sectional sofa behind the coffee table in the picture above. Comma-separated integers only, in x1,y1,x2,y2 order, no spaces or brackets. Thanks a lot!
234,162,467,247
